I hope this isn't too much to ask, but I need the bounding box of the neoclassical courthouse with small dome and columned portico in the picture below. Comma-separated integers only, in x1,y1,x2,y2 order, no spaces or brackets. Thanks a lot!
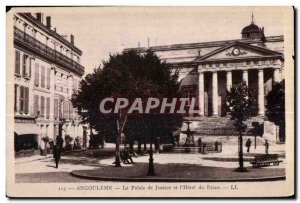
127,16,284,117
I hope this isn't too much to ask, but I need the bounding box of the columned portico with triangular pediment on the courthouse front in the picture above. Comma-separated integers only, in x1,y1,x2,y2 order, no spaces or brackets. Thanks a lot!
195,39,283,117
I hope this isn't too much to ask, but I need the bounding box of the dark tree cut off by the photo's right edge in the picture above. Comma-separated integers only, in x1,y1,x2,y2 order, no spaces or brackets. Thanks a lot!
266,80,285,142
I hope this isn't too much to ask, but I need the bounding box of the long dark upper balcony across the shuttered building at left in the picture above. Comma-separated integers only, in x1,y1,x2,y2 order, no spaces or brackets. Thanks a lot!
14,27,84,75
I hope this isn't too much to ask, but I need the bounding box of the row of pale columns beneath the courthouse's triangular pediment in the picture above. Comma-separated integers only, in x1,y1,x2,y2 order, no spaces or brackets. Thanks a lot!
198,66,281,117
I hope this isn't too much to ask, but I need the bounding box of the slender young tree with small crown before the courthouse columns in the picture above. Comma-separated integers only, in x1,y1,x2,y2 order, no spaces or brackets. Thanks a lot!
226,81,254,172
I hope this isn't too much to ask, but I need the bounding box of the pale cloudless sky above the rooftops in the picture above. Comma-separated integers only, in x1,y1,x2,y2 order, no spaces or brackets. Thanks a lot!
35,7,285,74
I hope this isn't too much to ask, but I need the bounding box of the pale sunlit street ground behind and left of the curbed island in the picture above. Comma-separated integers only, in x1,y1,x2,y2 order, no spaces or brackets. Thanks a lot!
15,145,286,183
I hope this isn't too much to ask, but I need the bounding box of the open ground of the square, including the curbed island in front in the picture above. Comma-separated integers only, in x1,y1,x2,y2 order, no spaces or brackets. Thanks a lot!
15,144,286,183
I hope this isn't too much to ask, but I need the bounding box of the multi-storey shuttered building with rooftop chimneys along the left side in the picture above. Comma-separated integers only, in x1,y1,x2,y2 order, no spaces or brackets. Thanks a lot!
13,13,87,154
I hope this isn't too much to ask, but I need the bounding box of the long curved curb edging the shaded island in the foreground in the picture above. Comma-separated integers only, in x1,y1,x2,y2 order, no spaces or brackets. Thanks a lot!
71,170,286,182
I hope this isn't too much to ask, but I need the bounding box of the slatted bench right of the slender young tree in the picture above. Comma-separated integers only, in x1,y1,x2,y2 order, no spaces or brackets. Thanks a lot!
250,154,282,167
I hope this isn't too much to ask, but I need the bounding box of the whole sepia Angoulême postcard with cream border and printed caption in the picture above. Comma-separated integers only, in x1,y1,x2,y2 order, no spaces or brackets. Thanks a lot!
6,7,295,198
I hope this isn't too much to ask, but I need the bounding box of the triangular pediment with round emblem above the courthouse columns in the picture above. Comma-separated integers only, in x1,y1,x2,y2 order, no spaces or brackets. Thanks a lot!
196,42,282,62
